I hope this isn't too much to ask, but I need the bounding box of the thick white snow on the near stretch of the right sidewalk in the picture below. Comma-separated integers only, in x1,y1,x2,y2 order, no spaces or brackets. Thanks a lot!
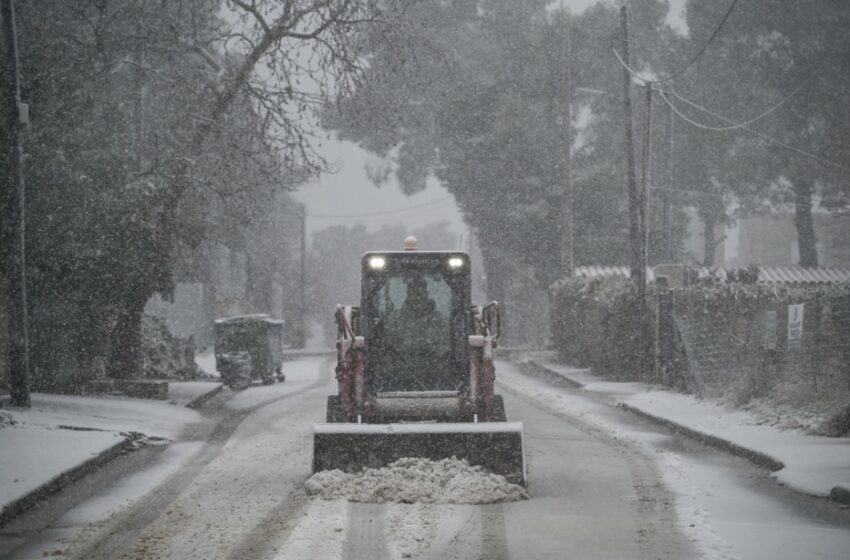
622,391,850,496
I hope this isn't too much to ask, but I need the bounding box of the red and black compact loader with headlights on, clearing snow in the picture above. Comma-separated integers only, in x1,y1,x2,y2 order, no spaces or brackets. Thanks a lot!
313,238,525,485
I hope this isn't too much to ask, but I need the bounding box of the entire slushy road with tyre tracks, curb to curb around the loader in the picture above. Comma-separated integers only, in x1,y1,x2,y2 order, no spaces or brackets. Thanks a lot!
9,357,850,560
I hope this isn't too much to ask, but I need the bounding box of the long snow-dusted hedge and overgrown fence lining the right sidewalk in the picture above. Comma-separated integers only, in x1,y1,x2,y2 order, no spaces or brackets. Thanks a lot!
550,275,850,435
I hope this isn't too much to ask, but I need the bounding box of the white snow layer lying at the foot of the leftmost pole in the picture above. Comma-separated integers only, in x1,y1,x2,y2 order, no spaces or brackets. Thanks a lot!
0,393,202,506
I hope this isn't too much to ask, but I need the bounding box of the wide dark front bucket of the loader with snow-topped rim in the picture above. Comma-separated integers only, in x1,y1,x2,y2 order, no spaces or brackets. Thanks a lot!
313,422,525,486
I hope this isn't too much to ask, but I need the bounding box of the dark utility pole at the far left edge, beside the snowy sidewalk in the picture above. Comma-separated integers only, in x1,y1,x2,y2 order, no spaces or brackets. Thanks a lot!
0,0,30,407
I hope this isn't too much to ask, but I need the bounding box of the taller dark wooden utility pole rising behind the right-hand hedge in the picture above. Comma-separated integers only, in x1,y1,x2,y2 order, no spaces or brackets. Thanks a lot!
620,6,646,294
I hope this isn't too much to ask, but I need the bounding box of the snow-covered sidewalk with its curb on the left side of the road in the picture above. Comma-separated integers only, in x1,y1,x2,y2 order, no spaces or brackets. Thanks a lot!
0,382,221,526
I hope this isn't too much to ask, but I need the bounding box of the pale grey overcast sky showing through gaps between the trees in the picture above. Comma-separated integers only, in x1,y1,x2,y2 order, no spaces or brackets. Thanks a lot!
295,0,687,245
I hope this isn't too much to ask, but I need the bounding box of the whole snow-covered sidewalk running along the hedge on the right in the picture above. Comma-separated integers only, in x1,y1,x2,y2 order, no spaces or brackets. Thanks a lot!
517,358,850,503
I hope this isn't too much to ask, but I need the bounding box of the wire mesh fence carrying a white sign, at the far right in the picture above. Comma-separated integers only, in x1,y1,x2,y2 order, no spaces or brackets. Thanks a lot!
656,289,850,397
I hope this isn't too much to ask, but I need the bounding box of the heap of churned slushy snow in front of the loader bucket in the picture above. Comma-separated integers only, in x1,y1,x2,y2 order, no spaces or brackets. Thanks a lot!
305,457,528,504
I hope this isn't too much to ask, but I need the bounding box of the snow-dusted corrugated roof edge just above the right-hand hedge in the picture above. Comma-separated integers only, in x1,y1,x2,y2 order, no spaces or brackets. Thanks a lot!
575,266,850,284
